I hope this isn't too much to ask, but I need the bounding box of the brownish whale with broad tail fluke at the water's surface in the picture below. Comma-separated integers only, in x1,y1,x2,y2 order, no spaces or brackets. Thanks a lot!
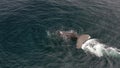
59,30,91,49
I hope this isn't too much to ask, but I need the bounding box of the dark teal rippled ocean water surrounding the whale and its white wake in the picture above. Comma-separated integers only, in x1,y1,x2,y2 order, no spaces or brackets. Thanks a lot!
0,0,120,68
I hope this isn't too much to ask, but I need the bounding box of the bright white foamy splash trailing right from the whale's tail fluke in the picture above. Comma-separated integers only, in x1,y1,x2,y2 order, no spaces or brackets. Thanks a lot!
82,39,120,58
